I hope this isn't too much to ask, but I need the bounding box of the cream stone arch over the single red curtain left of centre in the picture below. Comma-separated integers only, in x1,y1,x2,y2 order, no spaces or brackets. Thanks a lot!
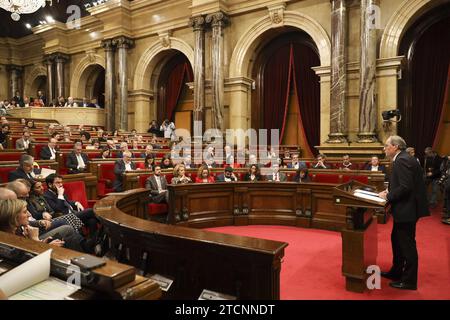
133,37,194,91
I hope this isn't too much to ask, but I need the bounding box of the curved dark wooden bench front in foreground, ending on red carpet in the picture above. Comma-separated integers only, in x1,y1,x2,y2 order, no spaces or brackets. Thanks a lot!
94,189,287,300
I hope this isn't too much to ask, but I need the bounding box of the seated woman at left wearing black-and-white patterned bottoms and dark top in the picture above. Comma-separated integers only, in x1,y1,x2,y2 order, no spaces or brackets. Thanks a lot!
27,181,83,231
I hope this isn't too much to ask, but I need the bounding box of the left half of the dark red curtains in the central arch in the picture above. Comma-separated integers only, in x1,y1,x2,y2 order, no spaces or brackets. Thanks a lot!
263,44,292,135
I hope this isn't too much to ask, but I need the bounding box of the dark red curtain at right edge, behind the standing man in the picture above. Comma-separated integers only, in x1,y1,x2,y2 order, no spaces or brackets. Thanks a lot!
400,18,450,157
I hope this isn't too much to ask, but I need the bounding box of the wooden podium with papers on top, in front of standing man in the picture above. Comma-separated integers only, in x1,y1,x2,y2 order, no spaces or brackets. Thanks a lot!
333,181,385,293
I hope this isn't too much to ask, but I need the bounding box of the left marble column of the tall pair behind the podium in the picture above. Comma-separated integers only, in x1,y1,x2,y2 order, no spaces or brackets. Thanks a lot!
327,0,347,143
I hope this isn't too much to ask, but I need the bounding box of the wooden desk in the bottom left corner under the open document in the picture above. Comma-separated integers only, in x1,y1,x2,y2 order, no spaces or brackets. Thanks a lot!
0,232,161,300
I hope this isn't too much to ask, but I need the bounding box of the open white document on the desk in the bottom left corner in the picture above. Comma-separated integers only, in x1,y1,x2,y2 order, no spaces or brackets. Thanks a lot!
0,249,78,300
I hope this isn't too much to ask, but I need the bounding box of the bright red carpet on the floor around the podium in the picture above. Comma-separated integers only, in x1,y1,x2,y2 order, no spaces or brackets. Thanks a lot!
208,210,450,300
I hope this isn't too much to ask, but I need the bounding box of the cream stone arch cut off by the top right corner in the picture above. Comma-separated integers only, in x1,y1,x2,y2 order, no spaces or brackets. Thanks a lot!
380,0,450,59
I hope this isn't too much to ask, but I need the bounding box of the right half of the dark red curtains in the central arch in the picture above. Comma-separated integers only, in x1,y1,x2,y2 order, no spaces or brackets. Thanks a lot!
292,43,320,155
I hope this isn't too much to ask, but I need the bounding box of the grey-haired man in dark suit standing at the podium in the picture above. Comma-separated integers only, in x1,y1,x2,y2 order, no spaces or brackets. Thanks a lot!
379,136,429,290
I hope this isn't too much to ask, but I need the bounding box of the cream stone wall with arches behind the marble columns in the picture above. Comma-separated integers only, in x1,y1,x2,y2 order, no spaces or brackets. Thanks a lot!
0,0,448,146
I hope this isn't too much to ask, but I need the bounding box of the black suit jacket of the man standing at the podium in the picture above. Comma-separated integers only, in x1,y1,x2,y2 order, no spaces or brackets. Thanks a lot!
387,151,430,223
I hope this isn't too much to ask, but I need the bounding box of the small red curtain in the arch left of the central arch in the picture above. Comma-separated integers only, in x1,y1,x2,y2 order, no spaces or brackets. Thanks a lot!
165,62,193,120
